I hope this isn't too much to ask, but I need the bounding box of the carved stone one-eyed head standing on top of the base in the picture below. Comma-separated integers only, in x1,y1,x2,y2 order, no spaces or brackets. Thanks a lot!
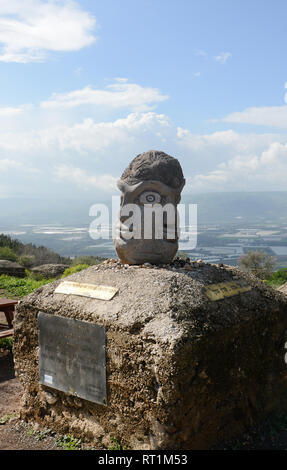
114,151,185,264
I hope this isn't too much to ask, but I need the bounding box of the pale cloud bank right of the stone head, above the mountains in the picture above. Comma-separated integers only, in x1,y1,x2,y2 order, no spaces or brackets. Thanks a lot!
177,128,287,192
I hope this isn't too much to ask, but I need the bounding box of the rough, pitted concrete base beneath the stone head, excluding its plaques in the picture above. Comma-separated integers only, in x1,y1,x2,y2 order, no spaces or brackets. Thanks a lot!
14,263,287,449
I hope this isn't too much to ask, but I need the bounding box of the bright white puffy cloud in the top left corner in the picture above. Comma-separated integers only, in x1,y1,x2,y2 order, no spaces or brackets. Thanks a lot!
0,0,96,63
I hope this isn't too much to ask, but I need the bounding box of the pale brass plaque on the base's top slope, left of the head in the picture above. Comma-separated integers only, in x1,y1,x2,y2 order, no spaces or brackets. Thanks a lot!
55,281,119,300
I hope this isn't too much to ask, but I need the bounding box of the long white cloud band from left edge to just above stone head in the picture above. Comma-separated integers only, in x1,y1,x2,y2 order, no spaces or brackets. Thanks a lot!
0,112,173,158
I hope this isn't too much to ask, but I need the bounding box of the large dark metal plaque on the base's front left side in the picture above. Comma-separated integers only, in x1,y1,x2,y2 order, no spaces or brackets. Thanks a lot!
38,312,107,405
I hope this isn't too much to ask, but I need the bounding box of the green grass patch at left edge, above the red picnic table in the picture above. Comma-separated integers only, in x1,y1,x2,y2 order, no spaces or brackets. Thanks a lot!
0,274,55,297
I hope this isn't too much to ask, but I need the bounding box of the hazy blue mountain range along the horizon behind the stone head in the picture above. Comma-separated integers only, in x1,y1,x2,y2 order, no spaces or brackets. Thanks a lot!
0,191,287,231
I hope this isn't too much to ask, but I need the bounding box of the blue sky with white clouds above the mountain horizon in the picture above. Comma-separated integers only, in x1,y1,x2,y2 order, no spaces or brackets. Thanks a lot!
0,0,287,198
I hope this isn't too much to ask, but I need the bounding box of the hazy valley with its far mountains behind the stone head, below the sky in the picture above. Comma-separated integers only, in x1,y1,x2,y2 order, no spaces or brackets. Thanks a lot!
0,192,287,267
